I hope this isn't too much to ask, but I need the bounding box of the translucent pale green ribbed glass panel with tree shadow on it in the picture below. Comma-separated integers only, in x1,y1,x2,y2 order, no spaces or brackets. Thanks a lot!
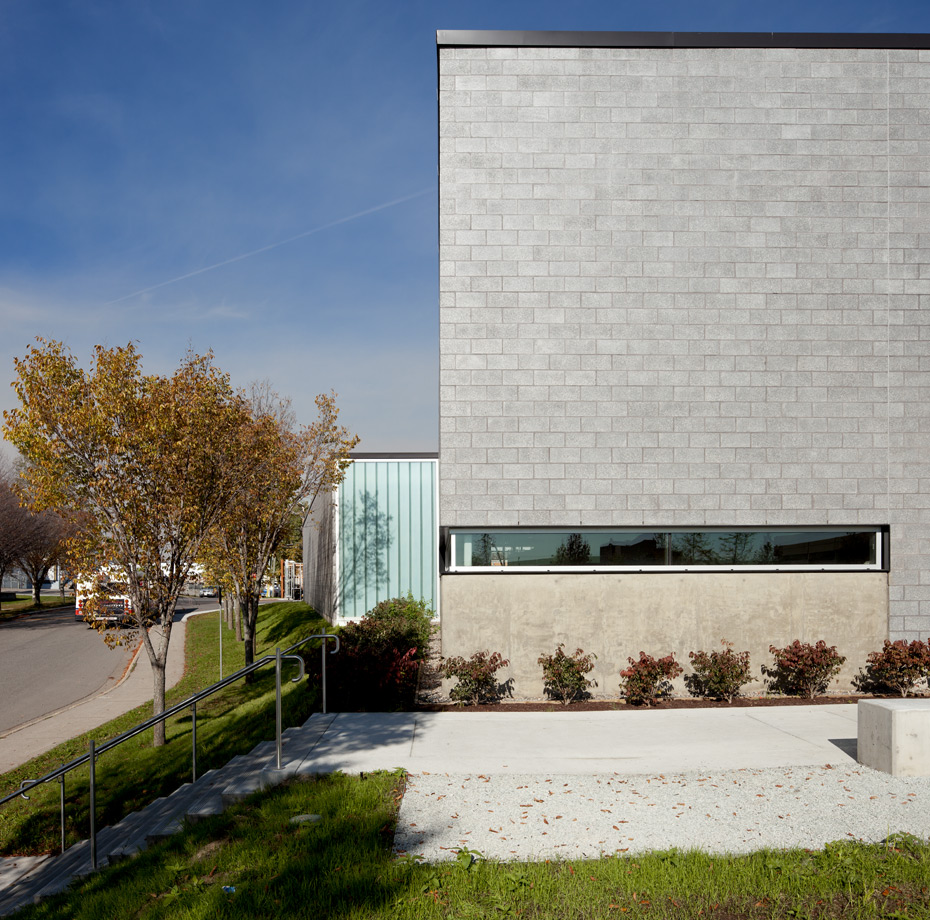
336,460,439,617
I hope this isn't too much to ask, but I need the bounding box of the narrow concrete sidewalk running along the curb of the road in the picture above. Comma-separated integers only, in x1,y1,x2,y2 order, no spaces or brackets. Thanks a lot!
0,611,204,773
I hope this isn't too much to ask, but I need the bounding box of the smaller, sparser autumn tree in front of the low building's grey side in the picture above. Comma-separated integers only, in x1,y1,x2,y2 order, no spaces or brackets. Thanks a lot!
200,384,359,665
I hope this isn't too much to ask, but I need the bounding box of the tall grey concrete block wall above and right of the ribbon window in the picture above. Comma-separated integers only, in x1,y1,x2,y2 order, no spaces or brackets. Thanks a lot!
439,37,930,638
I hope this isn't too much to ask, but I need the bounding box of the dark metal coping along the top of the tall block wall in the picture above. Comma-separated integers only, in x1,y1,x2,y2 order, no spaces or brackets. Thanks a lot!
436,29,930,49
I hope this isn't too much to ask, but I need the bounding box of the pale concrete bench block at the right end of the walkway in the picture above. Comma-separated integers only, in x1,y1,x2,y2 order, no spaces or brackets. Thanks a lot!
857,699,930,776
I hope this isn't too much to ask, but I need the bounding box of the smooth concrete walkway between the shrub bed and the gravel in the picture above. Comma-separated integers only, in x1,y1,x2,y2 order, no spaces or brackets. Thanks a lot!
294,704,856,774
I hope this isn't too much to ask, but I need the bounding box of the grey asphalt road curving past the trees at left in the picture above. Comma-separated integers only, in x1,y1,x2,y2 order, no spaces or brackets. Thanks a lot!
0,598,216,734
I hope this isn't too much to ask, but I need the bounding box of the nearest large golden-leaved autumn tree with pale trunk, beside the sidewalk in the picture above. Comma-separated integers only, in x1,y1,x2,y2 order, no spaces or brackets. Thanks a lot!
3,338,254,746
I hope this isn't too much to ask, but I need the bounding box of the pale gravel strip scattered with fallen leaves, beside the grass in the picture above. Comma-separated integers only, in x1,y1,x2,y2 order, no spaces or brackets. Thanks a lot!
394,766,930,862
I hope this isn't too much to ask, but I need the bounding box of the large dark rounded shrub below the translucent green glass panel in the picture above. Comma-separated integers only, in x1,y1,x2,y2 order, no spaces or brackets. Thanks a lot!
308,595,433,712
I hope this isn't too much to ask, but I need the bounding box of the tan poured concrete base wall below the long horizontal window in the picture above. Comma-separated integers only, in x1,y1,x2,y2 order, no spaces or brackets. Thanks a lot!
440,572,888,699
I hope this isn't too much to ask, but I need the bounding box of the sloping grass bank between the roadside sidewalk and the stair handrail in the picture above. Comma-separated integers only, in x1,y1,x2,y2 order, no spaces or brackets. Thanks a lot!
0,602,325,855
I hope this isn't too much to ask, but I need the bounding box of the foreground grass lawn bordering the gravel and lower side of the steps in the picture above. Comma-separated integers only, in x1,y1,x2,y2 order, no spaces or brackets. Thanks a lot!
7,773,930,920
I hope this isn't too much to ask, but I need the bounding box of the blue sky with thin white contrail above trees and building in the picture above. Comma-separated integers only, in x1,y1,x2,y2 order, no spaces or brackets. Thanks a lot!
0,0,930,451
